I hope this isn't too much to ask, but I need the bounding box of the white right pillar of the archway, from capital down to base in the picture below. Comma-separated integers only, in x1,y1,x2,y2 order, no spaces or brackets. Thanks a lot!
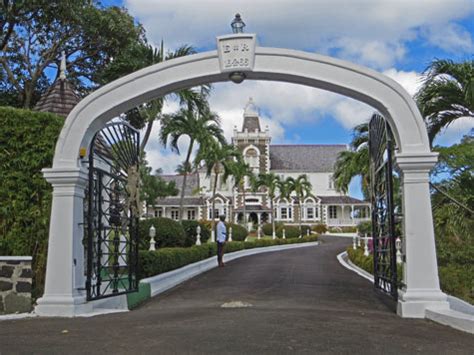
396,153,449,318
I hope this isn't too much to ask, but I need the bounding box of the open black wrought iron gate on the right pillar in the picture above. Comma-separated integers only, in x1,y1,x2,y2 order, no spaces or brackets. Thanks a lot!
369,114,398,300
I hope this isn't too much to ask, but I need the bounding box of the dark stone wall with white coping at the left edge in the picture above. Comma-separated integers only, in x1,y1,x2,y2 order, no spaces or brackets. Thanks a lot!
0,256,32,314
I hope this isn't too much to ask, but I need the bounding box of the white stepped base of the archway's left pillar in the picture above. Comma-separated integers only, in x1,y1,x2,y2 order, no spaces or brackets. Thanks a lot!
35,295,94,317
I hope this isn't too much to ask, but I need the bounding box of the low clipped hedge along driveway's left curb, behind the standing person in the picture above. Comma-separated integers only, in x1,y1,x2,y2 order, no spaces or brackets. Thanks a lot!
139,235,318,279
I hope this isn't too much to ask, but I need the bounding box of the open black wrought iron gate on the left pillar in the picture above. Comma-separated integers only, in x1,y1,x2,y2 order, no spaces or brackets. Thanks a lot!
84,122,140,300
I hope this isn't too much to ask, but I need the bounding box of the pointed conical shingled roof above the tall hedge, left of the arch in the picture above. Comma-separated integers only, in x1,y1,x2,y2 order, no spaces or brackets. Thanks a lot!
34,79,81,117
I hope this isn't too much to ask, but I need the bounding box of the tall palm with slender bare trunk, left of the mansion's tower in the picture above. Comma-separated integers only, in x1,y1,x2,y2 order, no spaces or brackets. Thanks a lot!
160,107,225,220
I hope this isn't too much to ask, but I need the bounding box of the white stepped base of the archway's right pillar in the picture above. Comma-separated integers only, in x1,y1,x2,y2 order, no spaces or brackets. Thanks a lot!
397,289,449,318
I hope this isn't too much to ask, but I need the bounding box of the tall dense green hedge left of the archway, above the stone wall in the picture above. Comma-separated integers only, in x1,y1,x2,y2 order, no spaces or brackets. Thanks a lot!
0,107,64,295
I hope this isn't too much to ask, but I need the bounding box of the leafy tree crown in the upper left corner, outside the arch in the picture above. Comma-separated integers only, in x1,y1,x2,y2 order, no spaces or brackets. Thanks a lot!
0,0,145,108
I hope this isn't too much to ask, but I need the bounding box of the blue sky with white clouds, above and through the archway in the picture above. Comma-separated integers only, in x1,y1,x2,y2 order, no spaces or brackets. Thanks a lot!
103,0,474,196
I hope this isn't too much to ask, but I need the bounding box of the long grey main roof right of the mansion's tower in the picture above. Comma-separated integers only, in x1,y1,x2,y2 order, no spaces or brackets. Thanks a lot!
270,144,347,173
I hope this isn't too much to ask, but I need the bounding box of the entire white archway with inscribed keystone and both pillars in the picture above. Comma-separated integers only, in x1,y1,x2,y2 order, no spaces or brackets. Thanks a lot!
36,34,448,317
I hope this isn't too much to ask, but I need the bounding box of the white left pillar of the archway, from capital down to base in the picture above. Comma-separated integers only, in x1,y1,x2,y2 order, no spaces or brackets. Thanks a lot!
35,168,92,317
